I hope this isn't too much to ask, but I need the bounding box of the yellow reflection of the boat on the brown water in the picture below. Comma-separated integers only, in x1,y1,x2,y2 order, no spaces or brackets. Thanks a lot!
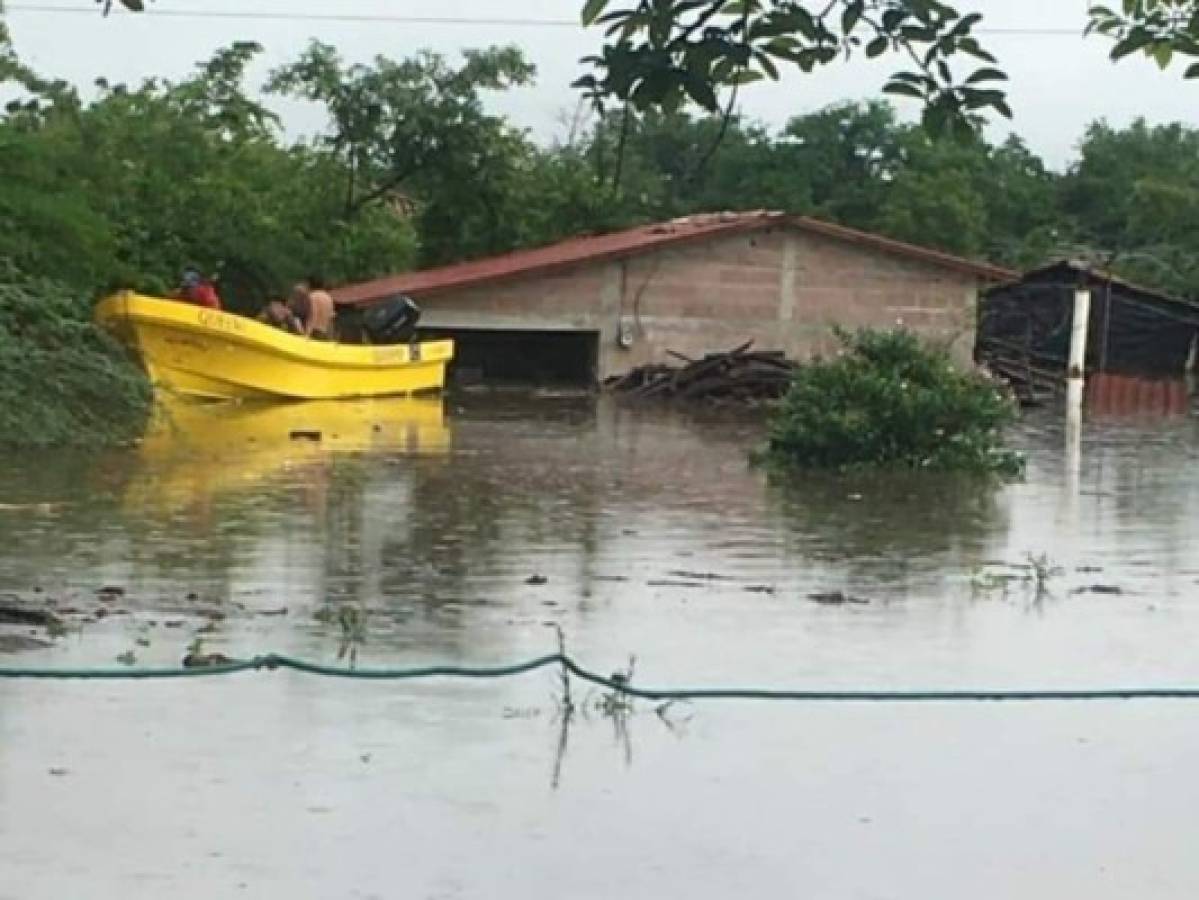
126,392,450,509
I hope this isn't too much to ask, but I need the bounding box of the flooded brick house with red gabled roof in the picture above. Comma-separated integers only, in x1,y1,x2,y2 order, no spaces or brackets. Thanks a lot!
335,212,1016,382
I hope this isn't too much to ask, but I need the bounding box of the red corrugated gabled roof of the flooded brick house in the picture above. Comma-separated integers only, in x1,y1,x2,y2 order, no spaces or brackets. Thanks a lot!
333,211,1019,304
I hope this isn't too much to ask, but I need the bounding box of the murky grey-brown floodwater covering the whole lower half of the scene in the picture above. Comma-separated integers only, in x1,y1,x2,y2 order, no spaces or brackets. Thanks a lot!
0,394,1199,900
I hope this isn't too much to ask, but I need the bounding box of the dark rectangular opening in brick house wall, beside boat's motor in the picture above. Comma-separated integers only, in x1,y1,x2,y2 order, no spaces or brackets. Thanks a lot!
420,328,600,387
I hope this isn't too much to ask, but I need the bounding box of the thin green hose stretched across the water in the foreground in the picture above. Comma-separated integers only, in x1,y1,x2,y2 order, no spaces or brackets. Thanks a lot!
0,653,1199,703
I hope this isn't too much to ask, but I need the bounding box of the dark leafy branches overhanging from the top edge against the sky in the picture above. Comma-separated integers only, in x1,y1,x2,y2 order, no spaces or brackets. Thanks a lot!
577,0,1199,133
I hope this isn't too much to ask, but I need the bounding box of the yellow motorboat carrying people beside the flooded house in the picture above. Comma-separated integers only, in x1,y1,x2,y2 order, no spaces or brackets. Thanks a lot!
96,291,453,400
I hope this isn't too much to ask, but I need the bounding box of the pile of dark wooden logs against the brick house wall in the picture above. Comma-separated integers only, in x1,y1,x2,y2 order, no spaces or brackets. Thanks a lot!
604,342,799,404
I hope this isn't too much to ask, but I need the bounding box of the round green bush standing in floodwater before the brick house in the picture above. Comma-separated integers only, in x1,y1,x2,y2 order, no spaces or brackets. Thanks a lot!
767,330,1024,476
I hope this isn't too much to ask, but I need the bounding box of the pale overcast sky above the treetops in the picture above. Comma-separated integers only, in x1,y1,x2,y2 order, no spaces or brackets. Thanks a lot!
6,0,1199,168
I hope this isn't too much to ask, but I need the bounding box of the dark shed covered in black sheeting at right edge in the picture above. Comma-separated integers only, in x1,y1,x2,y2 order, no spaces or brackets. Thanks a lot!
976,260,1199,382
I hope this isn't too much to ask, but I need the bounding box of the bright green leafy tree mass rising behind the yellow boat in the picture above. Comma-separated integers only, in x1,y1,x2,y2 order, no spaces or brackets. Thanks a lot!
0,43,416,309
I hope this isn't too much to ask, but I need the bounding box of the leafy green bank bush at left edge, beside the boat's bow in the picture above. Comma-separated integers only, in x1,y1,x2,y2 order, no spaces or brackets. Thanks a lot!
0,268,151,447
